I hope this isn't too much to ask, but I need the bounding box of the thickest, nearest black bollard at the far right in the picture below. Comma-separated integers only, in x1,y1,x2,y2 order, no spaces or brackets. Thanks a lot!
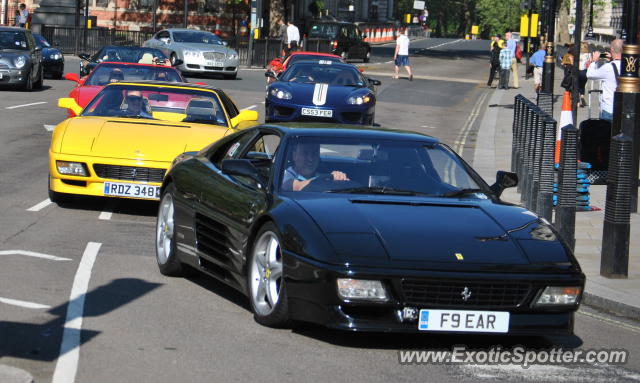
600,133,633,278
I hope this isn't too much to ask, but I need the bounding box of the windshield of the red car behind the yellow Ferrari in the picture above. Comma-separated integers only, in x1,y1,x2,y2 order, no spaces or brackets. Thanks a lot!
85,64,184,86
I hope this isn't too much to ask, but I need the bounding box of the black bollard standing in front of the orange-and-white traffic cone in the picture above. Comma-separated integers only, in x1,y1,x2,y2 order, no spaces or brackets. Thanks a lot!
556,125,578,251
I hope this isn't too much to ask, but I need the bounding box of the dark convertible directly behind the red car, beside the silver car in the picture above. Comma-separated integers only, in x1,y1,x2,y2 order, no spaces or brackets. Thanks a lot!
78,45,168,77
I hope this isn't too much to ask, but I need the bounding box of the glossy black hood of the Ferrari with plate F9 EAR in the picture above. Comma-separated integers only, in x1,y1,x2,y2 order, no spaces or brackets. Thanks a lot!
296,196,570,268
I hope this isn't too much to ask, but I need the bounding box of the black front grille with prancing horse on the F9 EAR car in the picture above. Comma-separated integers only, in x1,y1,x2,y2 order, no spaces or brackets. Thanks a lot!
401,279,530,307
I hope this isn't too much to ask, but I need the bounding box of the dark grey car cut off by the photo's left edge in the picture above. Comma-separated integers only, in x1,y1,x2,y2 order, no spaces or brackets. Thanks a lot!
0,27,43,91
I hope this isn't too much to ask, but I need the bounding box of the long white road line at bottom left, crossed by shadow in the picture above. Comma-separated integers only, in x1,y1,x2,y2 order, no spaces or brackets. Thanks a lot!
51,242,102,383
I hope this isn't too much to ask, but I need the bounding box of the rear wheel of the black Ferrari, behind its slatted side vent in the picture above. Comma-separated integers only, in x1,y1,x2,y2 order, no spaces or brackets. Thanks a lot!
156,184,185,277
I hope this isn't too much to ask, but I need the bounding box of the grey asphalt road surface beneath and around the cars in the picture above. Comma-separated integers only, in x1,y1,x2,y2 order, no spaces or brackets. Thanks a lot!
0,39,640,382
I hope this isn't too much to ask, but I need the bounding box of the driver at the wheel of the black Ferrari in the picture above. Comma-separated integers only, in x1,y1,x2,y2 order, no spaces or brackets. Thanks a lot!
282,143,349,191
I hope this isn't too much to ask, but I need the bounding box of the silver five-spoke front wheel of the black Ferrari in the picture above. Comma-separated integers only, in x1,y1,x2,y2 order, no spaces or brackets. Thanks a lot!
247,222,291,328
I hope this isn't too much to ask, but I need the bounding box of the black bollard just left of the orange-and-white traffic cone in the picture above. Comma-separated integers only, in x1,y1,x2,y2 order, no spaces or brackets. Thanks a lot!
537,115,557,222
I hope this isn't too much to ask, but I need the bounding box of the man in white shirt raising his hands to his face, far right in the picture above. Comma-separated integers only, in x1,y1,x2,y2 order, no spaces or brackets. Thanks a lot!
587,39,622,121
